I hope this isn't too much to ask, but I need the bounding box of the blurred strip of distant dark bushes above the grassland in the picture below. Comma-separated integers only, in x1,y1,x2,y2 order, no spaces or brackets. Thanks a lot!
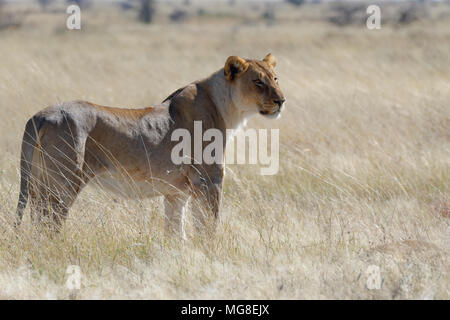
0,0,450,29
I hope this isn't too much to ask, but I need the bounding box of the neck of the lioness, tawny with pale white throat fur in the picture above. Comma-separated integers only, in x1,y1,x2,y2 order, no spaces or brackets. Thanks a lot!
206,69,252,136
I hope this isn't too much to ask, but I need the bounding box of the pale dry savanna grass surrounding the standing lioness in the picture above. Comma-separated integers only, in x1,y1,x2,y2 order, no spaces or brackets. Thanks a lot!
0,1,450,299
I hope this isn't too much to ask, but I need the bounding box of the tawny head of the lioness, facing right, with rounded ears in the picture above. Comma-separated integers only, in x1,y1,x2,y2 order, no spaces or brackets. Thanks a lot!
224,53,285,118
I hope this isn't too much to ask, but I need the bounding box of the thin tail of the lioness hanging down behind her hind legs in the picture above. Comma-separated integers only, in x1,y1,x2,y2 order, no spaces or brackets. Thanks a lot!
15,115,44,227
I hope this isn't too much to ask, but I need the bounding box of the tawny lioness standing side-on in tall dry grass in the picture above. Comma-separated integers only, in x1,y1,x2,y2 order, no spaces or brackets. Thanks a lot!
16,54,285,236
